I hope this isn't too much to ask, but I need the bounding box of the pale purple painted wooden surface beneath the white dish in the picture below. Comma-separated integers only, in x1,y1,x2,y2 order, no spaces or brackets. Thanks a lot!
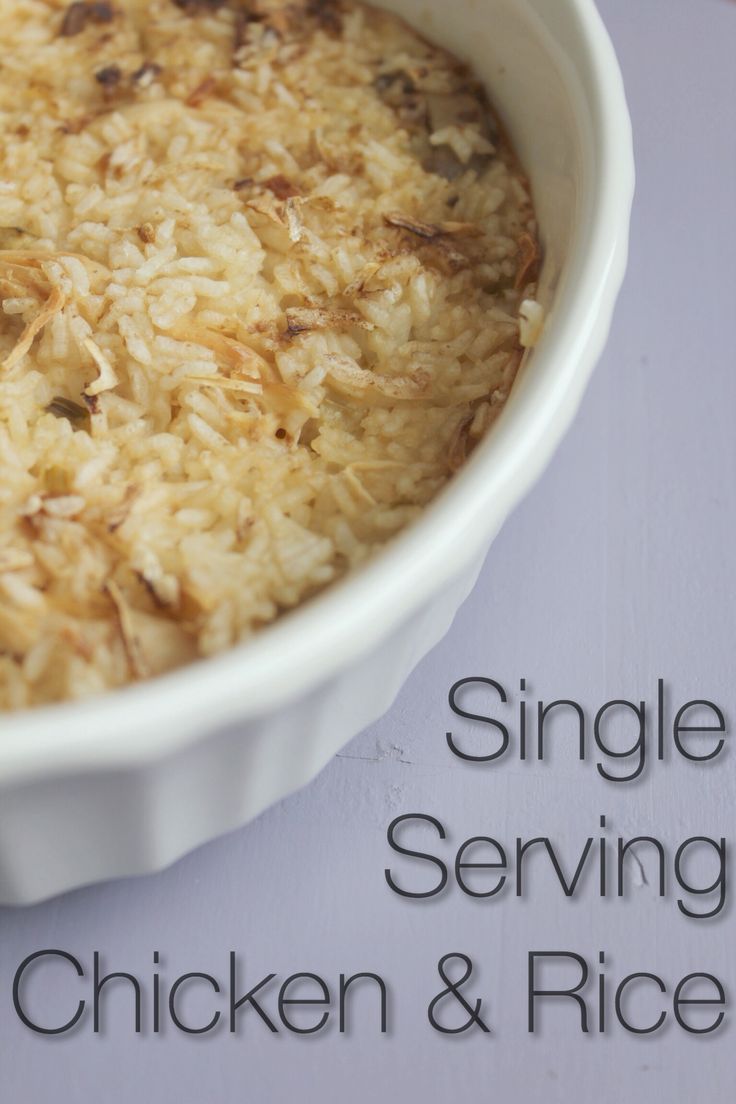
0,0,736,1104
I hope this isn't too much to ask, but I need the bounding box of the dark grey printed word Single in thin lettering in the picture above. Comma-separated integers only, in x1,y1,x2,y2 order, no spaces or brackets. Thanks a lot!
447,677,726,783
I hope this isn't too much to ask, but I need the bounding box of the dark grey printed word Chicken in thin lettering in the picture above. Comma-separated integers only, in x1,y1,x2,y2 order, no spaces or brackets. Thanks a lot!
13,949,388,1036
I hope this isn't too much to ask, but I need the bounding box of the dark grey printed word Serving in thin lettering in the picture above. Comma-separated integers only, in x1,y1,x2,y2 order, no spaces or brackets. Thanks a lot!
384,813,728,920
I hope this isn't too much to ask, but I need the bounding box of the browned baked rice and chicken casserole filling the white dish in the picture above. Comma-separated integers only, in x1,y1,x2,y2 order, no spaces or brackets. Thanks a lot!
0,0,541,709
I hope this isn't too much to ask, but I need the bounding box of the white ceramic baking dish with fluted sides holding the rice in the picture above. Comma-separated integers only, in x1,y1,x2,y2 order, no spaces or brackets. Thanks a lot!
0,0,633,903
